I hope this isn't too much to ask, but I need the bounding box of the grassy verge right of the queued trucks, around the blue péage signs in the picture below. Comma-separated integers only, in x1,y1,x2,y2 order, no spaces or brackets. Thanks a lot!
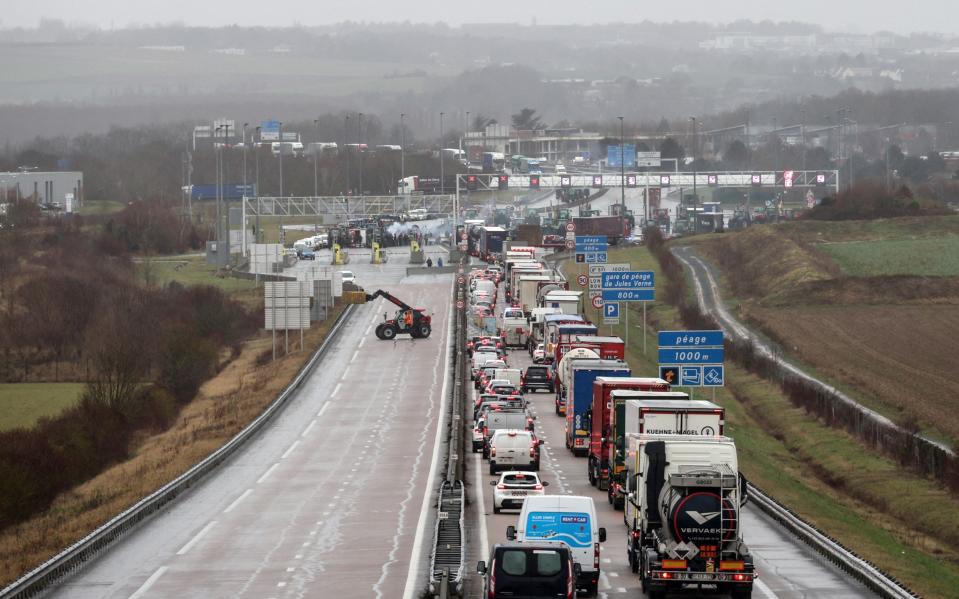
567,248,959,597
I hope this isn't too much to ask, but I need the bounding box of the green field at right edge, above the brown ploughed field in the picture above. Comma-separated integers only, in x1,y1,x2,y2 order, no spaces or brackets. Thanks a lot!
820,235,959,277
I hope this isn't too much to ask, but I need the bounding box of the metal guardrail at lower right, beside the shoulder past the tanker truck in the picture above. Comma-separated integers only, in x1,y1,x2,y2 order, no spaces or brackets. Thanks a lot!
749,483,918,599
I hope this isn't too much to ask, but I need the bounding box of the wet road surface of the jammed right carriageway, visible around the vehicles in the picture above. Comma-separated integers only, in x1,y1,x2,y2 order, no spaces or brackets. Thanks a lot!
466,278,875,599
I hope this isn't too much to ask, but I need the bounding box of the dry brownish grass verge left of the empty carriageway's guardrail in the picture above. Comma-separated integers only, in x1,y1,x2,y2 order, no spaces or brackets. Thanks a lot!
0,306,344,587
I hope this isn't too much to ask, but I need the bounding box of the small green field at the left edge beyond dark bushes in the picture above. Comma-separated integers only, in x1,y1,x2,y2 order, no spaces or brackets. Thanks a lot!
0,383,83,431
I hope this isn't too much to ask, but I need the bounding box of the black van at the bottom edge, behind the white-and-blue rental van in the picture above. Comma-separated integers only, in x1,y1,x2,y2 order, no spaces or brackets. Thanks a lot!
476,541,578,599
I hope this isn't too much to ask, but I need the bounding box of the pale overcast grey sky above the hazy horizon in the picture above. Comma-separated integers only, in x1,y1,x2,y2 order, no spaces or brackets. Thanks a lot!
7,0,959,33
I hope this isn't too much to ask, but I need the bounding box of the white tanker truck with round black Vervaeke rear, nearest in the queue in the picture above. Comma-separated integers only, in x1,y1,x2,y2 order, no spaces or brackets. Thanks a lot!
624,434,756,599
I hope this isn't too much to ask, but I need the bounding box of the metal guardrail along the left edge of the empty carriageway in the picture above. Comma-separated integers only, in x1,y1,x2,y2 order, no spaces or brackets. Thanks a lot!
0,305,354,599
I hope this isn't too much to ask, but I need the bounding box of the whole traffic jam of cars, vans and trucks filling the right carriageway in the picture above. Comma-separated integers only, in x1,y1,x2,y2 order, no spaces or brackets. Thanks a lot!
466,247,758,599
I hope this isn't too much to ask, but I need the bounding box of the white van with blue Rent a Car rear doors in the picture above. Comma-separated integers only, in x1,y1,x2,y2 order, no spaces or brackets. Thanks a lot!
506,495,606,597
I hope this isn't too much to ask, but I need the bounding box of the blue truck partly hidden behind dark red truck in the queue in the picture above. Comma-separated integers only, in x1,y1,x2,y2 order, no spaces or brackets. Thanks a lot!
566,360,632,456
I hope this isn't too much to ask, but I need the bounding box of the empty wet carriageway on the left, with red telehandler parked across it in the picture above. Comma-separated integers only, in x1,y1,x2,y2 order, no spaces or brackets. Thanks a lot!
51,248,452,599
